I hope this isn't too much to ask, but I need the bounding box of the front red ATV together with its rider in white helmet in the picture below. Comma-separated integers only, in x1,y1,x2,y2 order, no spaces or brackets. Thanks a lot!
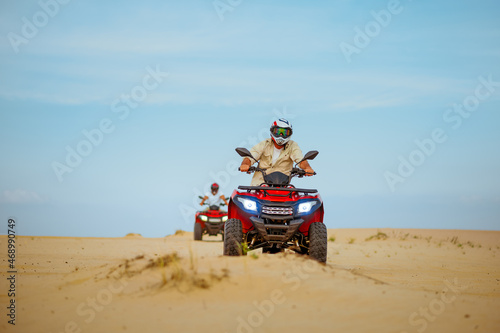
223,119,328,263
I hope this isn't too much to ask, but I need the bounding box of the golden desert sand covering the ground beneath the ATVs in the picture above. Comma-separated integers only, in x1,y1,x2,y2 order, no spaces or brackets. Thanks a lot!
0,229,500,333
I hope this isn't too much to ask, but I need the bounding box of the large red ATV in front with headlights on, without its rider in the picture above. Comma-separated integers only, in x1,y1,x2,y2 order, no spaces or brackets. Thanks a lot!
224,148,328,262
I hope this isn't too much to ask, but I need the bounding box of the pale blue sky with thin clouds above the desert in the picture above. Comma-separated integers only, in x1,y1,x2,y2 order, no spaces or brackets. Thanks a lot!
0,0,500,237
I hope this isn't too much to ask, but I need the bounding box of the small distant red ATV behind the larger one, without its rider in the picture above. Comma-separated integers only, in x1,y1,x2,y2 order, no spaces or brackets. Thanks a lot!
194,196,227,240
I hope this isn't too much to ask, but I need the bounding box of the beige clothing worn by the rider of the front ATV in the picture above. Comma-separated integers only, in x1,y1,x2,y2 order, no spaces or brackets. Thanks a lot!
250,139,304,186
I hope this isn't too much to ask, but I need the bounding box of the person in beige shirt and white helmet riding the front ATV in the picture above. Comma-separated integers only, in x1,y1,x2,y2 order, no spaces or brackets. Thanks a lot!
240,118,314,186
